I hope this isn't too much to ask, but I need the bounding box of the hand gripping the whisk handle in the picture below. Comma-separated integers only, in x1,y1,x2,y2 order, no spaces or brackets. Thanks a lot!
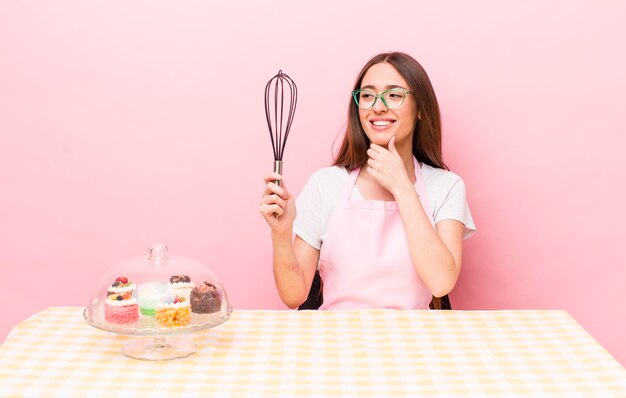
261,173,296,234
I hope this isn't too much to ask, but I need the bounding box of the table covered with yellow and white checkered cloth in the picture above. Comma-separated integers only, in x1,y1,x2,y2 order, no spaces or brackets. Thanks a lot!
0,307,626,398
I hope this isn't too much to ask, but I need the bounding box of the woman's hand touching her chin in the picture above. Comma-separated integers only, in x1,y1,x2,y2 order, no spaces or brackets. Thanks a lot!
367,136,413,197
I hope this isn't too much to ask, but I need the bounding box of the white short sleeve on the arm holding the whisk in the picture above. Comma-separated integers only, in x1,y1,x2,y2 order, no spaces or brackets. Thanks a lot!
293,176,323,250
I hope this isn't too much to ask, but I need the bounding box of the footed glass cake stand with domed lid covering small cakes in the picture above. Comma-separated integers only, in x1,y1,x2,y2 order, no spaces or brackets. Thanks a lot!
83,244,232,360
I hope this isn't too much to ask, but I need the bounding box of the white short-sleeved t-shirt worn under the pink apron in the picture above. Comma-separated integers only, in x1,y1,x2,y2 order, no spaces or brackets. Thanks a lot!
293,163,476,250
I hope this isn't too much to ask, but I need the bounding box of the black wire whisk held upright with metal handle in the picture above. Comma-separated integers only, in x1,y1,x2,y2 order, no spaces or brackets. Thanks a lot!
265,70,298,185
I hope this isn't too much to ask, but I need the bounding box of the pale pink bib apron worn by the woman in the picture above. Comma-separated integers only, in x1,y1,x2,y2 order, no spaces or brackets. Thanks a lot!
319,158,435,309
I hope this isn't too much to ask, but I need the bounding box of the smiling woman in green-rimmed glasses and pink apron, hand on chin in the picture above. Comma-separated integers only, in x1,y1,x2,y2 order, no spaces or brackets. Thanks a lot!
260,52,475,309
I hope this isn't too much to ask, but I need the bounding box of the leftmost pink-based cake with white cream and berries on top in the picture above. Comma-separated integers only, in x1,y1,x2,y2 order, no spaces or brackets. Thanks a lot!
104,276,139,324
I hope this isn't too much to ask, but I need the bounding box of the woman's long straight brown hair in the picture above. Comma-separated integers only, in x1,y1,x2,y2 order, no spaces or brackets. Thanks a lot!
333,52,448,170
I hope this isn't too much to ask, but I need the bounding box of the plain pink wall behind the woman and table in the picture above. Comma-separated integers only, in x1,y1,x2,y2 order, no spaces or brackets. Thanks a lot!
0,0,626,364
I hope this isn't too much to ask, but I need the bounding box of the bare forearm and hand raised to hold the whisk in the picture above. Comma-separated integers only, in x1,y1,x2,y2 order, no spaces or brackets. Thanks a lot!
260,173,319,308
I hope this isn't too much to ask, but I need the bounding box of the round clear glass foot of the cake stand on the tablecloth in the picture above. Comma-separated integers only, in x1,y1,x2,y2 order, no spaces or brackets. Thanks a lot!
122,337,198,361
